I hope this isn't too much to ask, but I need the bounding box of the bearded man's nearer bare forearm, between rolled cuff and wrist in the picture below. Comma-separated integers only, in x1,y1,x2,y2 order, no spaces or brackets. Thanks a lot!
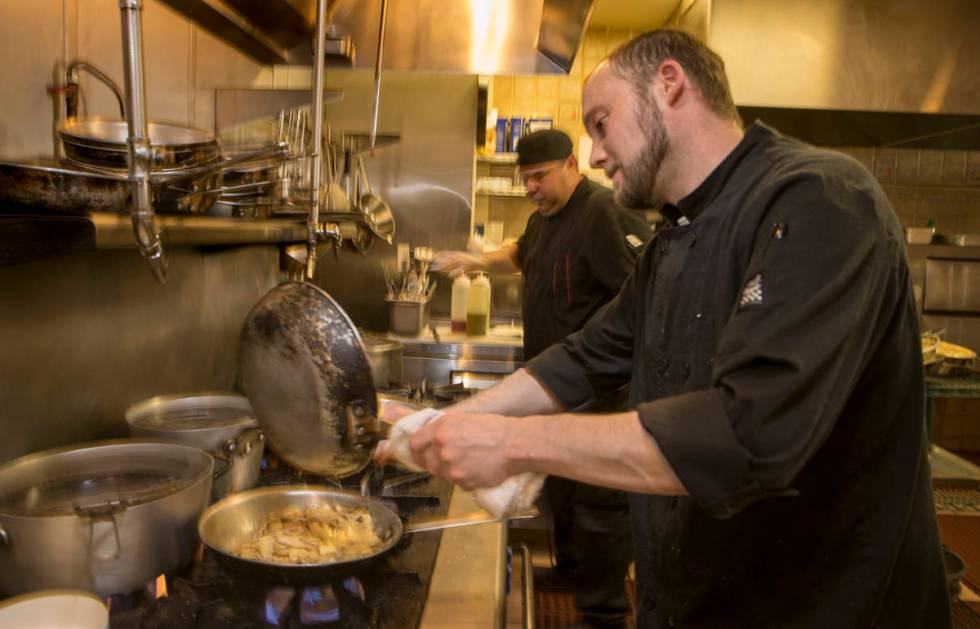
505,411,687,496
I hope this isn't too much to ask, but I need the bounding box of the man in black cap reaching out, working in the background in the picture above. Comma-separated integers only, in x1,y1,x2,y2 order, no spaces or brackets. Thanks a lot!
433,129,651,626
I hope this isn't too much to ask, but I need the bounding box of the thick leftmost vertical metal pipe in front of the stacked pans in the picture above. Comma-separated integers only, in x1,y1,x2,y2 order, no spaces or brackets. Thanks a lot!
119,0,167,284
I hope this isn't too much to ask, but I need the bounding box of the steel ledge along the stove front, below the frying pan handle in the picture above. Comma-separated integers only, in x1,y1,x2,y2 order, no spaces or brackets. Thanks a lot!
419,487,507,629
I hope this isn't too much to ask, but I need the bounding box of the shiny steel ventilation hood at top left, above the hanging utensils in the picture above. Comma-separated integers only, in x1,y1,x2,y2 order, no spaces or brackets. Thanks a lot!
162,0,595,74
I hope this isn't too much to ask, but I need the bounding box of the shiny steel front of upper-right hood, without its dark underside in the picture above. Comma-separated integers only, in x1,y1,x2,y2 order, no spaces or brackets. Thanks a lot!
708,0,980,114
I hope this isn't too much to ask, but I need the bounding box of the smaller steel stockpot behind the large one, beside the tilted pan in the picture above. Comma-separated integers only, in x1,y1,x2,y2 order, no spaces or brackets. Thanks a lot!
126,391,265,499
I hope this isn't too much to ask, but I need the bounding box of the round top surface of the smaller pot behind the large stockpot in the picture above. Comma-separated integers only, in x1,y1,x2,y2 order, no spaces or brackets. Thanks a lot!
126,392,258,432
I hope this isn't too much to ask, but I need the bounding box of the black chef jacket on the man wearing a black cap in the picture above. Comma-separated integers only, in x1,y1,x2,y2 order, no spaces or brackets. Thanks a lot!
517,177,651,360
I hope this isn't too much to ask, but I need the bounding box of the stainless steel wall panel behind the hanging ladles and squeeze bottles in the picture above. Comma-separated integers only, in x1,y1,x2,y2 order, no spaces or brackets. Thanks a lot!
316,70,477,330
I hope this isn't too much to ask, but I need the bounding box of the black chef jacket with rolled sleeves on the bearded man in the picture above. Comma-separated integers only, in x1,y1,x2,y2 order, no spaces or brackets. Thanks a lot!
528,123,951,628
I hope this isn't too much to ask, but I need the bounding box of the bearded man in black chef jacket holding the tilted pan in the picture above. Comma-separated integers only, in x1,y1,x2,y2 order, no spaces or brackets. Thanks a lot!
382,30,951,628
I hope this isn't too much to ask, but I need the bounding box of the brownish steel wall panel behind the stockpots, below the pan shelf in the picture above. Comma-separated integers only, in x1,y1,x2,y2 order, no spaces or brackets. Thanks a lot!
0,246,279,462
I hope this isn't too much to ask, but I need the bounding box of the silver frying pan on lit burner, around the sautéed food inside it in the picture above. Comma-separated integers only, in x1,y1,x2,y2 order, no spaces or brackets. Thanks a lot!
197,485,538,585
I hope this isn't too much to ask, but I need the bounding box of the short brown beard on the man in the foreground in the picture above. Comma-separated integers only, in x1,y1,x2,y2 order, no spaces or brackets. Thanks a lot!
615,97,670,208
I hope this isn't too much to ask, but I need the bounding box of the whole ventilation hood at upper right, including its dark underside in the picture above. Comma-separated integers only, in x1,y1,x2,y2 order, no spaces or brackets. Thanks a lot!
688,0,980,150
